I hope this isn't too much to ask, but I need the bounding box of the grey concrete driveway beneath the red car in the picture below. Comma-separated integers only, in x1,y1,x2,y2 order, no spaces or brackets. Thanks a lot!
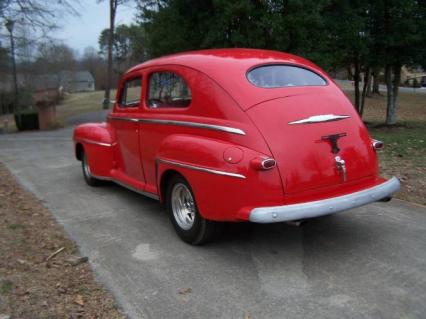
0,125,426,319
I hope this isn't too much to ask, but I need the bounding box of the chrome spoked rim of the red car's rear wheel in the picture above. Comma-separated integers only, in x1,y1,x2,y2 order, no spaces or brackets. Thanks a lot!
171,183,196,230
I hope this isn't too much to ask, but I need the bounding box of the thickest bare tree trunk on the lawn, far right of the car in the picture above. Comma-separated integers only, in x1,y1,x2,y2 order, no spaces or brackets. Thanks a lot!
385,64,401,125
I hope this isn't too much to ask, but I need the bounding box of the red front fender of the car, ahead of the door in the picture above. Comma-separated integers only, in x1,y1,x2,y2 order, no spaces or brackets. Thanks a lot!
73,123,116,178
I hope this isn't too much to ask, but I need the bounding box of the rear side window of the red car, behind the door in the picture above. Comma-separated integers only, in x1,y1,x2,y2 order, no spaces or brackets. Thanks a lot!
148,72,192,108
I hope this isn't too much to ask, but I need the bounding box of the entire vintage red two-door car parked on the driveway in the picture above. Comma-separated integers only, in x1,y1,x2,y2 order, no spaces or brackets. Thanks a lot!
74,49,400,244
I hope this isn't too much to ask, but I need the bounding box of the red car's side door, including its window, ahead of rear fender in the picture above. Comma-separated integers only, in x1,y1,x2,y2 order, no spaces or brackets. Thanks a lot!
110,73,145,183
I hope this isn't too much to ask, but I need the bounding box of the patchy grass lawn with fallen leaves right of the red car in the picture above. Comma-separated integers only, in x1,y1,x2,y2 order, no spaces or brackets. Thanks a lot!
347,92,426,205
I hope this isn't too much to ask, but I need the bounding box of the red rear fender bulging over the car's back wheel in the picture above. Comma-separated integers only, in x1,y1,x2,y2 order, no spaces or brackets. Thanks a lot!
157,134,283,221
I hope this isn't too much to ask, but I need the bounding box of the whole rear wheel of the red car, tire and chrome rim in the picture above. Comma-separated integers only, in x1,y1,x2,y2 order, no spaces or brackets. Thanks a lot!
166,175,218,245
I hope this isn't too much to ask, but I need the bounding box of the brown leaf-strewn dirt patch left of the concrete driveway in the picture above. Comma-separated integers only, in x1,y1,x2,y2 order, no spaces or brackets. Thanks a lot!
0,163,125,319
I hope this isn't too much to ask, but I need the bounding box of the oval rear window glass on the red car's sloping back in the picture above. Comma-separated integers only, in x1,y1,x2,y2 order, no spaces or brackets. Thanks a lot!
247,65,327,88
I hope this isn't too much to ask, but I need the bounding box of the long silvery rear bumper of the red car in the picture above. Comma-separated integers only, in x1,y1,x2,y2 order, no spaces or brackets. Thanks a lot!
249,177,400,223
